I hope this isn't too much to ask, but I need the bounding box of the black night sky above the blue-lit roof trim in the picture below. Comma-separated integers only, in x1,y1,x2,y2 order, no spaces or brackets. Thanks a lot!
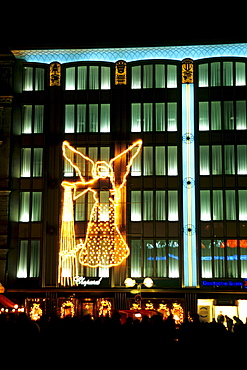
0,7,247,49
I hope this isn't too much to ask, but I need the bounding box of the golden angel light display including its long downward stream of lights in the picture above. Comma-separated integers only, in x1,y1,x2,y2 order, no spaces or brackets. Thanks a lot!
59,140,142,285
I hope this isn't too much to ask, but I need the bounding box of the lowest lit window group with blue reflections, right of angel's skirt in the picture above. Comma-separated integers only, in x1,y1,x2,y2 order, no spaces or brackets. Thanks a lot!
130,239,179,278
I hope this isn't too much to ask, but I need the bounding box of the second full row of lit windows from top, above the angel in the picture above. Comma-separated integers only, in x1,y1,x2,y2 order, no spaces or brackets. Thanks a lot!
21,100,247,134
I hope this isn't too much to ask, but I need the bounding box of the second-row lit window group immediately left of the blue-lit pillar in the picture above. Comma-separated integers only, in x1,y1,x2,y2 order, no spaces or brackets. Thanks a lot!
131,102,177,132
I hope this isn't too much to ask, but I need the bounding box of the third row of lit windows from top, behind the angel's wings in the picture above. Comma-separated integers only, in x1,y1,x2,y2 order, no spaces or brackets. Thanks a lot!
18,145,247,177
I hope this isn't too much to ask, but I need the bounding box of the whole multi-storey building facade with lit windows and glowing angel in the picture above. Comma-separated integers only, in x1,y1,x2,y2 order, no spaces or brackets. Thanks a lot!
0,44,247,321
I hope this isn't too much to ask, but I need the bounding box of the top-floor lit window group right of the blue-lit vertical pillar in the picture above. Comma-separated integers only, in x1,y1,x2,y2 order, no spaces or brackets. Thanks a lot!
198,61,246,87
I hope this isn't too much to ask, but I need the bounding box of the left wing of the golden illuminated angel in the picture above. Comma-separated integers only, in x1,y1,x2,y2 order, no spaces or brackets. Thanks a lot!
62,141,94,184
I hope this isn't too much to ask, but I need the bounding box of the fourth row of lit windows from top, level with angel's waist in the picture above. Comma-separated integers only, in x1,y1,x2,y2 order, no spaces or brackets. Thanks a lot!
19,190,247,222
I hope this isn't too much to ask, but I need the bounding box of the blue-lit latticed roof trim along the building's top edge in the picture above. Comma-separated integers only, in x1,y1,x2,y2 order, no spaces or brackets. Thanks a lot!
11,43,247,64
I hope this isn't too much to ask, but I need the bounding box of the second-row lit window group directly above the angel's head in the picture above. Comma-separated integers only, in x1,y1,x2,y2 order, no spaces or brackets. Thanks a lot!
65,104,110,133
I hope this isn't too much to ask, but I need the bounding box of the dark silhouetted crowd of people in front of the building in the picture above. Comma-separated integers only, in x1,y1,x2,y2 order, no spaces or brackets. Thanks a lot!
0,311,247,361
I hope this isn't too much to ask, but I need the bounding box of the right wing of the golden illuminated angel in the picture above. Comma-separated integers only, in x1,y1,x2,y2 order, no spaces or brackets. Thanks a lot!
110,139,142,187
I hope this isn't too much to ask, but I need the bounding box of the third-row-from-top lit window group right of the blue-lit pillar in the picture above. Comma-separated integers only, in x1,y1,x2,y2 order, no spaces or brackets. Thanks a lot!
199,145,247,176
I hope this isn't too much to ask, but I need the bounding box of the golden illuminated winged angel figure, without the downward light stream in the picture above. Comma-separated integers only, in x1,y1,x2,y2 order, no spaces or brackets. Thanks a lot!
62,140,142,267
